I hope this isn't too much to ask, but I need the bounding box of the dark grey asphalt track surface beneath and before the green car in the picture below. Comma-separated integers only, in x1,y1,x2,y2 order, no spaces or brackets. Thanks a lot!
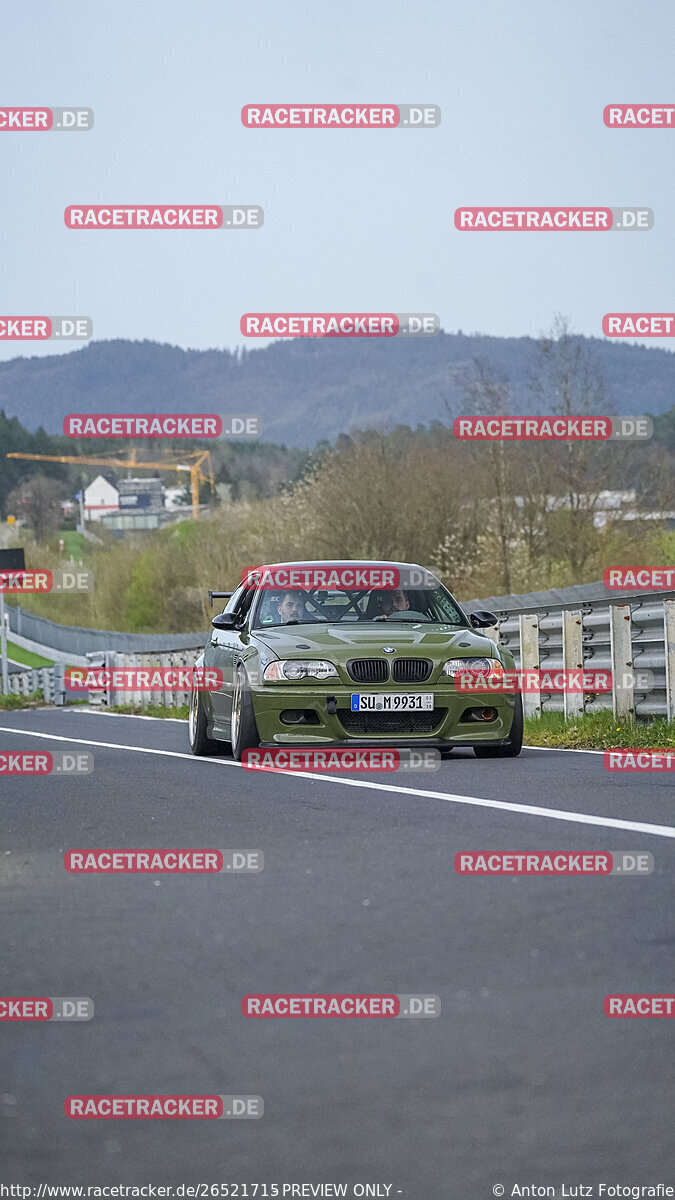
0,709,675,1200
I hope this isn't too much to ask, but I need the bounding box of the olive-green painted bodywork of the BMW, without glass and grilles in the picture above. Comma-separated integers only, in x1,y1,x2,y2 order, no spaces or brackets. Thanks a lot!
191,564,520,752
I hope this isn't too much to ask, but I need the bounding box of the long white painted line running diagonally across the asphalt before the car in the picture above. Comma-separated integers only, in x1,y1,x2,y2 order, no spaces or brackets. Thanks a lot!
0,725,675,838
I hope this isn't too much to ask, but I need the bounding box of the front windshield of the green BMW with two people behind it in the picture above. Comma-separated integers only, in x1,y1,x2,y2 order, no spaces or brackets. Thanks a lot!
253,587,467,629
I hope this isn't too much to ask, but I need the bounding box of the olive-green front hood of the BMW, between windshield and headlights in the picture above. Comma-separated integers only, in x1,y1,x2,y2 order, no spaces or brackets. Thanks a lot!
253,622,495,662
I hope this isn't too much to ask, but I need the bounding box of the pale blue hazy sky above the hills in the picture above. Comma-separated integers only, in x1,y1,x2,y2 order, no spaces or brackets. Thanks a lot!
0,0,675,360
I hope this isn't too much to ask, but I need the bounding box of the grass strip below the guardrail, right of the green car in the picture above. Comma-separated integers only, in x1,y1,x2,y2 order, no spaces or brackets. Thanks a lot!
524,712,675,750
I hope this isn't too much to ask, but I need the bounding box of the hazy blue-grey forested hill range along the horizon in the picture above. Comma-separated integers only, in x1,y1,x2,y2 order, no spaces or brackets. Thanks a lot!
0,332,675,446
